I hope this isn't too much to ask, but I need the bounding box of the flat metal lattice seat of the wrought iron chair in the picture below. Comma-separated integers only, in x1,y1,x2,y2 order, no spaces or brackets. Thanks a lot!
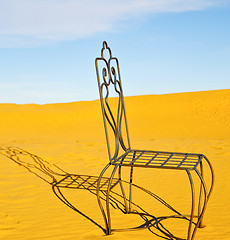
112,150,204,170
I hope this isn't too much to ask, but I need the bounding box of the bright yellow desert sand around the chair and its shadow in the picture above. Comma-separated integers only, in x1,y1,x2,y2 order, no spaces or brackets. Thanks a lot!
0,90,230,240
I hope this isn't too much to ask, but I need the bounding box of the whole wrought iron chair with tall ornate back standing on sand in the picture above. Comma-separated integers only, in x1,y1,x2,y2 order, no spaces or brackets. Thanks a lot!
95,41,214,240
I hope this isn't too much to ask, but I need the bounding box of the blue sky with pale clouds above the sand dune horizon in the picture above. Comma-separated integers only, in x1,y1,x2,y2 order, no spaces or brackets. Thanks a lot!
0,0,230,104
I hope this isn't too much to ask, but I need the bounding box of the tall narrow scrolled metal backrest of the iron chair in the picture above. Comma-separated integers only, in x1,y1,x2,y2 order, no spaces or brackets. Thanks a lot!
95,41,130,161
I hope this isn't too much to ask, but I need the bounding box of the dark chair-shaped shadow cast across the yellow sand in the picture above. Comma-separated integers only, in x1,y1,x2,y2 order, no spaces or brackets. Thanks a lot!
0,147,192,239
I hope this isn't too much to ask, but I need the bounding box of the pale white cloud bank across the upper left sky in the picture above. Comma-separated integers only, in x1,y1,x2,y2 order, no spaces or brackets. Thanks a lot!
0,0,224,47
